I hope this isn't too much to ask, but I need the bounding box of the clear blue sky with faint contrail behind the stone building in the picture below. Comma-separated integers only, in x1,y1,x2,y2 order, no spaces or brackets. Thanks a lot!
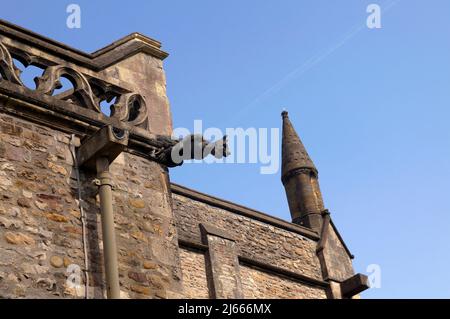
0,0,450,298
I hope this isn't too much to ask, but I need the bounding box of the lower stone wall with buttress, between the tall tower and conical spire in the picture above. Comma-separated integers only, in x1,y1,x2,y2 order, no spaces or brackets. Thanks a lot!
172,185,326,298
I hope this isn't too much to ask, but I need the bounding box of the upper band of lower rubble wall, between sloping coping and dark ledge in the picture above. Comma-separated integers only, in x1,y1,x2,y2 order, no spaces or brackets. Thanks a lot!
173,194,322,279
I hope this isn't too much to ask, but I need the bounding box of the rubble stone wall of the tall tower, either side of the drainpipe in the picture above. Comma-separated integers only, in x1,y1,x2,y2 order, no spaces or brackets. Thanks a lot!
0,113,181,298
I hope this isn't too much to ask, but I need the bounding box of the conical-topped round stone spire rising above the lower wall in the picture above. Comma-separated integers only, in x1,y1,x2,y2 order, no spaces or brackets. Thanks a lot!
281,111,324,231
